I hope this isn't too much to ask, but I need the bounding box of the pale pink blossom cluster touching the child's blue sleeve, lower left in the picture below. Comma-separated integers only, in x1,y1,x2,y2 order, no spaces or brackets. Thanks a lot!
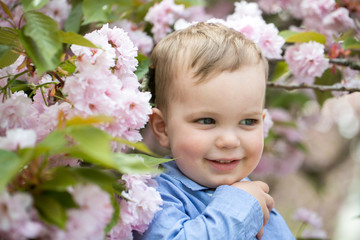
107,175,162,240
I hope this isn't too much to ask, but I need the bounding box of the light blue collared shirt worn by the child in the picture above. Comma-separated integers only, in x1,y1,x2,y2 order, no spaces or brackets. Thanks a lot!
134,161,295,240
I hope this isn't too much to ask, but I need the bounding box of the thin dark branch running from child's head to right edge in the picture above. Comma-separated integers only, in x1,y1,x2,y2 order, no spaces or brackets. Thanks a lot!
267,82,360,93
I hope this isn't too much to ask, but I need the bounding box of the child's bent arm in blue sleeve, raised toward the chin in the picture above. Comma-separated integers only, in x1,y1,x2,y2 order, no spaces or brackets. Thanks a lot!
136,184,263,240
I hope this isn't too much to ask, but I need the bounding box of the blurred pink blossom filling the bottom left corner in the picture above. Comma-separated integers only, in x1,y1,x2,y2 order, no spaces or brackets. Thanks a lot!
0,192,43,240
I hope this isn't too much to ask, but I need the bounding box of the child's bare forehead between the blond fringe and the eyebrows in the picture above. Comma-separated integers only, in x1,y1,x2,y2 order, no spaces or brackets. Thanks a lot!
170,64,266,110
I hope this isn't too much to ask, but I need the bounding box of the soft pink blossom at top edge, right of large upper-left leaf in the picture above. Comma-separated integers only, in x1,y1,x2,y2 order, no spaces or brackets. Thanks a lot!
40,0,71,29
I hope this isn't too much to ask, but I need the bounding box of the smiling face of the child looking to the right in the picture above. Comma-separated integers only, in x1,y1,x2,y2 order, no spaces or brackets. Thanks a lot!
159,64,265,188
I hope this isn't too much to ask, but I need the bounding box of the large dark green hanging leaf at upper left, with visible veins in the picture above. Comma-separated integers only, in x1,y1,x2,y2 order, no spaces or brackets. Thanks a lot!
20,11,62,75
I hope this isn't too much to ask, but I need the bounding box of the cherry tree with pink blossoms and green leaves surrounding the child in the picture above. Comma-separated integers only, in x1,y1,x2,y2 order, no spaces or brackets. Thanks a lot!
0,0,360,239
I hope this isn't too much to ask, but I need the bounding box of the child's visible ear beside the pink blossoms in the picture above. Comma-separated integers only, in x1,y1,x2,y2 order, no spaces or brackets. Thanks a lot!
149,108,170,148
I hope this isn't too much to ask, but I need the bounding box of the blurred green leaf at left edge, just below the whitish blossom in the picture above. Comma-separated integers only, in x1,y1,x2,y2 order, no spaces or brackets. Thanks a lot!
0,149,24,192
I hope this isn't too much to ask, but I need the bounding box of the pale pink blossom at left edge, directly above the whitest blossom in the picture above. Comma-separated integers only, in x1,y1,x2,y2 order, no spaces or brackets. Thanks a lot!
0,91,38,135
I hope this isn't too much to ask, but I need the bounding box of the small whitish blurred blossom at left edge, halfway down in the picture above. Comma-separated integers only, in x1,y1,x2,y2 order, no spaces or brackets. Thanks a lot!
0,128,36,151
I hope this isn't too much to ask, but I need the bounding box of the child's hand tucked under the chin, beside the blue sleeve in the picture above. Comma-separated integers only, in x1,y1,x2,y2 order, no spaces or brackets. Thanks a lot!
232,181,275,240
